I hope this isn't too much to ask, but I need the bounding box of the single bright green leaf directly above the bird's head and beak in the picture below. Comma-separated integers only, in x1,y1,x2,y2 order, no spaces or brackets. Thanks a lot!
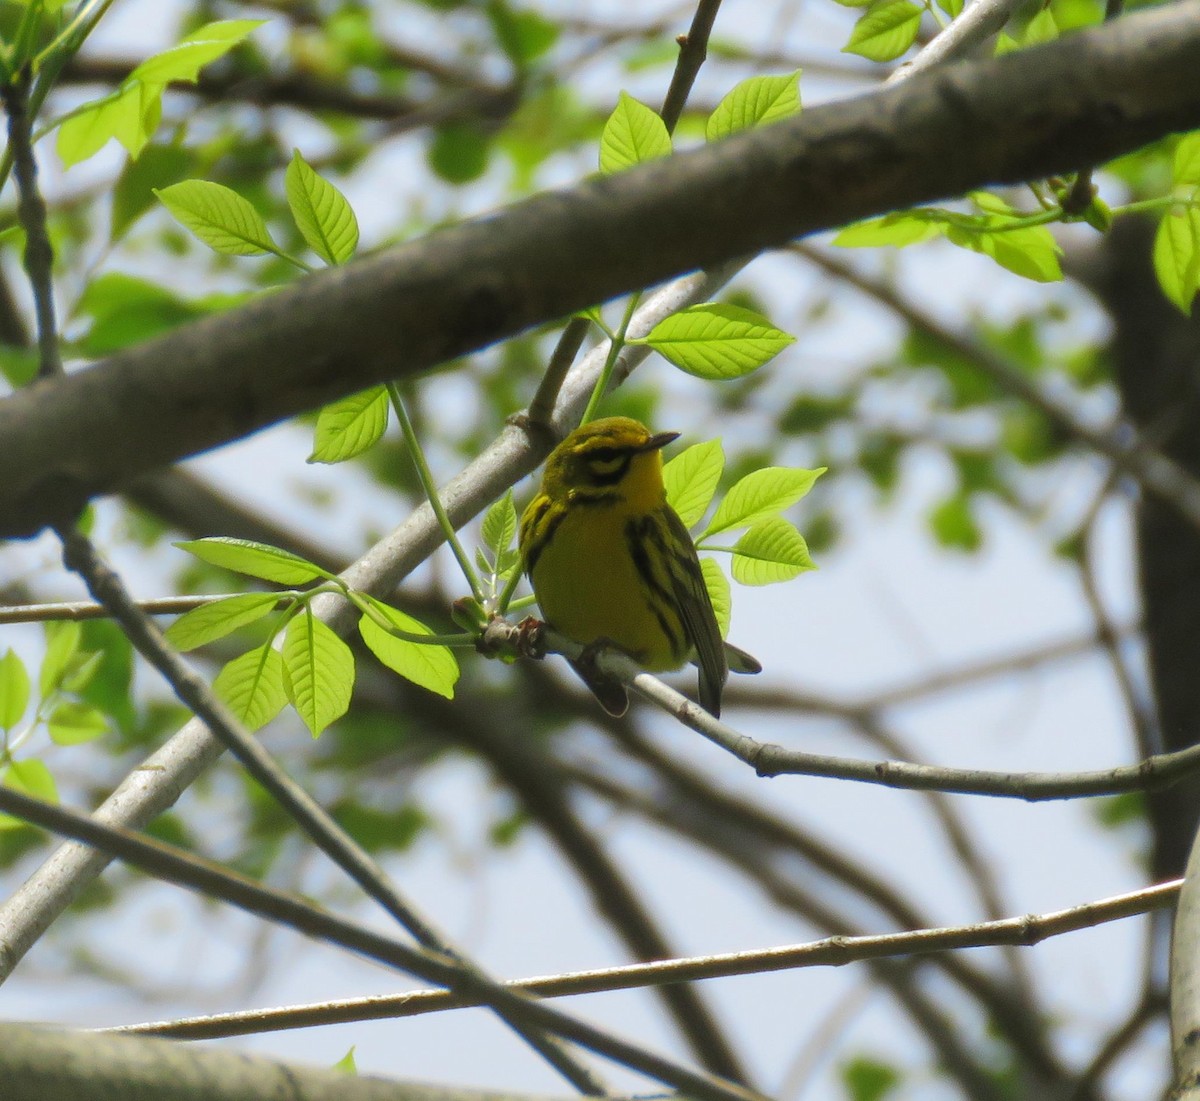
640,302,796,379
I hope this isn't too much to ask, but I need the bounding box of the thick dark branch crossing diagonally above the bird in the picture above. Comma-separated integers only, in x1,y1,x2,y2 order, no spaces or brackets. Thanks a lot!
0,0,1200,536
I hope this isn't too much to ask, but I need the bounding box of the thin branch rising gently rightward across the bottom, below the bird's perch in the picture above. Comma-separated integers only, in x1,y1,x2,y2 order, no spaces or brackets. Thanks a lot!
108,877,1182,1040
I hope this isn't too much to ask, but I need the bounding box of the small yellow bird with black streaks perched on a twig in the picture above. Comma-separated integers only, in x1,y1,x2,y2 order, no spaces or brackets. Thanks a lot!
518,416,762,717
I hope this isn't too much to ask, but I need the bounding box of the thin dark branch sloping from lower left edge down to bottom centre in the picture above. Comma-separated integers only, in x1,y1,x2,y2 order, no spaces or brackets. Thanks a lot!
0,786,763,1101
